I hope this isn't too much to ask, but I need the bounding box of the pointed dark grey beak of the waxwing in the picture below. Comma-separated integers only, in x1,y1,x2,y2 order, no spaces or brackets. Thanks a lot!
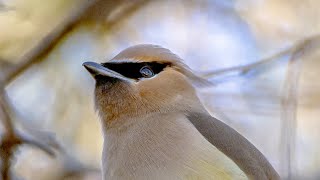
82,62,134,82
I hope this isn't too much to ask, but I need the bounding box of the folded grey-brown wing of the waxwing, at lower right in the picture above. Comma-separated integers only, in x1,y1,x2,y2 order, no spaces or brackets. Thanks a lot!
187,113,280,180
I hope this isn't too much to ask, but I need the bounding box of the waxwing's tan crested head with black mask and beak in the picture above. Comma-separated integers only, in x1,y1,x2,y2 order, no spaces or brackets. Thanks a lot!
83,45,205,127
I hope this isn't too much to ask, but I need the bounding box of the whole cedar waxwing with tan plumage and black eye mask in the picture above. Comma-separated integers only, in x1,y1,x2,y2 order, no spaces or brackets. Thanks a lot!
83,45,280,180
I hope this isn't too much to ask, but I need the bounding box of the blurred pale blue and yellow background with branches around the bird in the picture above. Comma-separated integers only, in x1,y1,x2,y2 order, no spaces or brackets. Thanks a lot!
0,0,320,180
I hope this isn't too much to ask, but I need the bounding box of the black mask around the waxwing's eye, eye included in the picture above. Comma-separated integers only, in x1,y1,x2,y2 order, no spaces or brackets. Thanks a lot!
101,62,170,80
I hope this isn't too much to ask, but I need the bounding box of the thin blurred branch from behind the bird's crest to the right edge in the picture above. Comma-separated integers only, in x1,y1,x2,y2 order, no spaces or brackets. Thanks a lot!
201,35,320,82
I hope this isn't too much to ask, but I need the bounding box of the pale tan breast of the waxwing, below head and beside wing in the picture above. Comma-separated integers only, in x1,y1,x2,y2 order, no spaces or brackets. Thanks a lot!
102,113,246,179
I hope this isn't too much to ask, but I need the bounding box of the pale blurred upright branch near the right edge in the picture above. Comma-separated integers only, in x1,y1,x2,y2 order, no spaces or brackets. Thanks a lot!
281,38,311,179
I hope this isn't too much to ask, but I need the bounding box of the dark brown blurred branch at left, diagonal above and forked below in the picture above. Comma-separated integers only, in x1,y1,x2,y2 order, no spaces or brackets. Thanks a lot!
0,0,97,177
